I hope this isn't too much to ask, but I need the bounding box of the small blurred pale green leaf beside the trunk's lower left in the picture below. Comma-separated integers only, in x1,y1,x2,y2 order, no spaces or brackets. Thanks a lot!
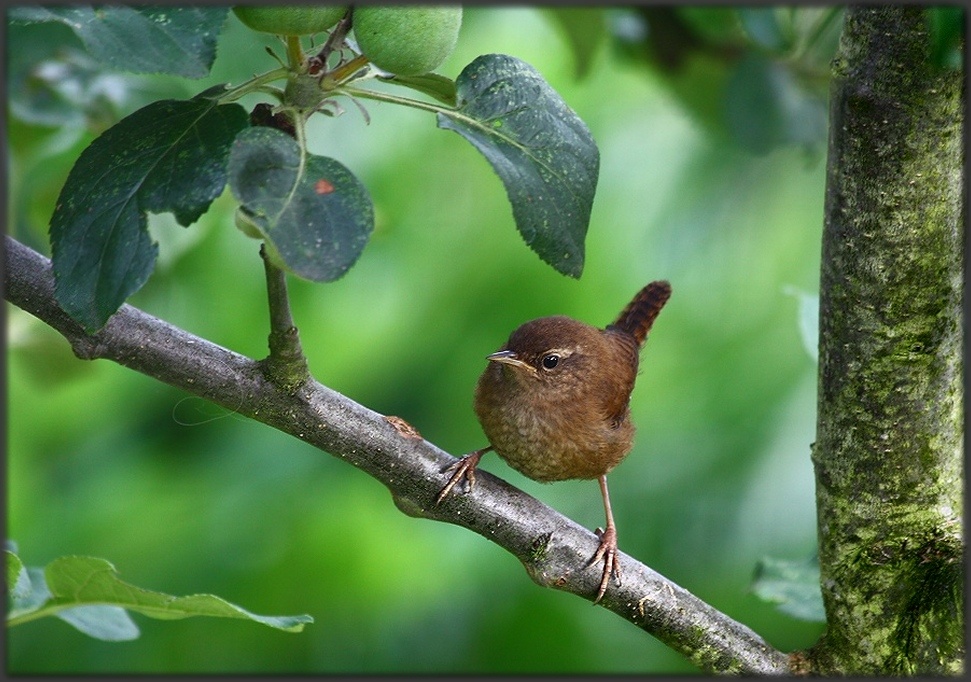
752,556,826,623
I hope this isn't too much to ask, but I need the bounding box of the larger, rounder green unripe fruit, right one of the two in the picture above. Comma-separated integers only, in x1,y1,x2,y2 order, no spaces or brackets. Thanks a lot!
353,5,462,76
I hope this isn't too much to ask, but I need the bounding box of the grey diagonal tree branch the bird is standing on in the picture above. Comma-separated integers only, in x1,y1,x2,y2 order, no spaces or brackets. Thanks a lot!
4,237,791,674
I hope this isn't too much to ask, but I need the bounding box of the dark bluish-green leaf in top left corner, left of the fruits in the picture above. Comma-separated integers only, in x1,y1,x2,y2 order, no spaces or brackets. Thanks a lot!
9,6,229,78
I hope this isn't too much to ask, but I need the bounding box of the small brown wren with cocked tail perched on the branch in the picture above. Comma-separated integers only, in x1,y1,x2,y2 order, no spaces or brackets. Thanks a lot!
436,280,671,604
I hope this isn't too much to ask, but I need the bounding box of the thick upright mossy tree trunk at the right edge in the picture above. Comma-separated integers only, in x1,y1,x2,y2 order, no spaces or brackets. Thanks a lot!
808,6,964,675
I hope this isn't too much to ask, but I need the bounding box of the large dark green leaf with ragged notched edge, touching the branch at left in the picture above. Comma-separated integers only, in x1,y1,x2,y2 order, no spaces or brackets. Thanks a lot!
50,93,248,333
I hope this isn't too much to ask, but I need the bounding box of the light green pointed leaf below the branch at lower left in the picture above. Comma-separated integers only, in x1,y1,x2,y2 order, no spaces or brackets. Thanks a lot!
8,556,313,641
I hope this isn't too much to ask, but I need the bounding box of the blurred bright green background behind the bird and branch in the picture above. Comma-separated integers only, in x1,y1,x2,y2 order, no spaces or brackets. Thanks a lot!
6,7,839,673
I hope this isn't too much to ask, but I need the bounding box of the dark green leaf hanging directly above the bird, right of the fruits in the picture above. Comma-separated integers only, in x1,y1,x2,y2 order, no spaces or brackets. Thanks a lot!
438,54,600,277
